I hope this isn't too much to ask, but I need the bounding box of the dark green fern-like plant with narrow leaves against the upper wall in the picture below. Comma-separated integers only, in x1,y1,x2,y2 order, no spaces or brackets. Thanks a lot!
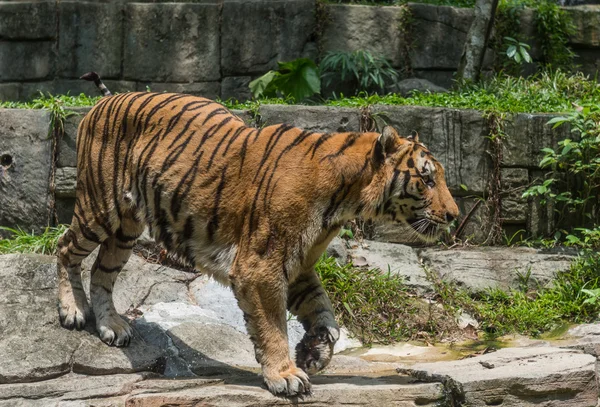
320,50,398,94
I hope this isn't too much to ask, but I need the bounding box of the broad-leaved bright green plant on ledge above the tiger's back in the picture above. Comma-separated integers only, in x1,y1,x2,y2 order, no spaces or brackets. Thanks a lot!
250,58,321,102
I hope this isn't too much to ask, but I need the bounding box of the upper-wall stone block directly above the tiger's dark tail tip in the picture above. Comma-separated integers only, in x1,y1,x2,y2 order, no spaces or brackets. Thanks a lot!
57,0,123,78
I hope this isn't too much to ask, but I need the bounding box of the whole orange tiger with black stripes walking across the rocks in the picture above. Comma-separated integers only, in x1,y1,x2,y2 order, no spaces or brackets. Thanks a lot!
57,73,458,397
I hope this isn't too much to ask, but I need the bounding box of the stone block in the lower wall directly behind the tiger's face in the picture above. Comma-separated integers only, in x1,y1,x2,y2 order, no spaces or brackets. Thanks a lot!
372,105,491,193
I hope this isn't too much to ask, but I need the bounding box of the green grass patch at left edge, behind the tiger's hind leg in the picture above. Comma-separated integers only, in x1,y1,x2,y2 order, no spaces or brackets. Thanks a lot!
0,225,68,254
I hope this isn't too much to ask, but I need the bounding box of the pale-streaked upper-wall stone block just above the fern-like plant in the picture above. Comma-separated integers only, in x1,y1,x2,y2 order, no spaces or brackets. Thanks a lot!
321,4,410,68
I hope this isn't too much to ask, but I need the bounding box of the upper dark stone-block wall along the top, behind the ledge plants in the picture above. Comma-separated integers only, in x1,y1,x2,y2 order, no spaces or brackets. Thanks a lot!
0,0,600,100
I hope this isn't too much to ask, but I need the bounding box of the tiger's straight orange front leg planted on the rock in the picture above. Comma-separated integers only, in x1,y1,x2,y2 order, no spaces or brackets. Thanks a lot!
230,254,311,396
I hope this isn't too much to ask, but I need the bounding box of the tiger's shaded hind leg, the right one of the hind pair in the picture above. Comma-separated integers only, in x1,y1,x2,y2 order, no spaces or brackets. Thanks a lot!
90,219,144,346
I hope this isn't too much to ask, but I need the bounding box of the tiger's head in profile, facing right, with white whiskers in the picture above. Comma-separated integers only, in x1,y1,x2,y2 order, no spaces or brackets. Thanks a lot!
372,126,459,242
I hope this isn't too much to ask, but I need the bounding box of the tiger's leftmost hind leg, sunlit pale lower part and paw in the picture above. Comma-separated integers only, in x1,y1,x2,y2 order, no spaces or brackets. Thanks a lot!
57,222,100,329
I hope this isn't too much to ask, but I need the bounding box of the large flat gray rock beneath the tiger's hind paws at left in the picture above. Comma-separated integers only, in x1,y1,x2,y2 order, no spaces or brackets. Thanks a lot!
0,254,162,384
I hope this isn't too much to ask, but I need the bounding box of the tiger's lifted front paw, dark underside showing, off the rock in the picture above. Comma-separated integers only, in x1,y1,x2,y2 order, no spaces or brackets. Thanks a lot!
296,326,340,374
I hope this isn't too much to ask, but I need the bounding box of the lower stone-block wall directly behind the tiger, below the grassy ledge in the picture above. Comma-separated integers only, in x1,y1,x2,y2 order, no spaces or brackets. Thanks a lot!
0,105,569,242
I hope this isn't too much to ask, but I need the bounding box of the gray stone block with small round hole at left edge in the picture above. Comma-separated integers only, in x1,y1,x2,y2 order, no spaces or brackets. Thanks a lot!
0,109,52,231
